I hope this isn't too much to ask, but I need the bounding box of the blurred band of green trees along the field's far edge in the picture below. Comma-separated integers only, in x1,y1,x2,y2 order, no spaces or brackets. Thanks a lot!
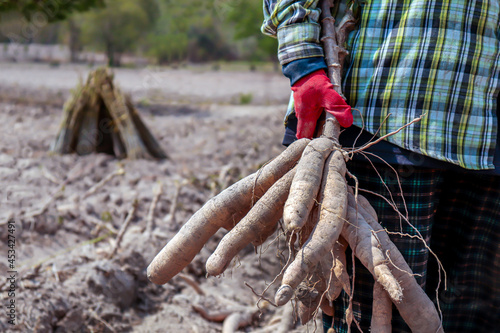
0,0,277,69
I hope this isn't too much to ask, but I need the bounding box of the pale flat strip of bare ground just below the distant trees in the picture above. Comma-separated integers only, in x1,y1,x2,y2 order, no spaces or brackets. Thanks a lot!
0,63,290,105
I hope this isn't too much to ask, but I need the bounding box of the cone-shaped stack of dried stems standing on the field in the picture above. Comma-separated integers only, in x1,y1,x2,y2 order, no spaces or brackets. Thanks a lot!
51,68,167,159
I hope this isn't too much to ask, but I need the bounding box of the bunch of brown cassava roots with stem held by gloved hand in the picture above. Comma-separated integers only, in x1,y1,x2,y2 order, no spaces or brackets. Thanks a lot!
148,0,443,333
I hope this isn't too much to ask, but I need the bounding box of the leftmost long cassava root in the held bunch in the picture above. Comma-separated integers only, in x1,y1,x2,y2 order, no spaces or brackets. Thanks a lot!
147,139,310,284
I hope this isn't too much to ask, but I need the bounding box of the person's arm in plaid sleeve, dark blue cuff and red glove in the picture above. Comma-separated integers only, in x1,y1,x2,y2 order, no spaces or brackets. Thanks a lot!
261,0,352,139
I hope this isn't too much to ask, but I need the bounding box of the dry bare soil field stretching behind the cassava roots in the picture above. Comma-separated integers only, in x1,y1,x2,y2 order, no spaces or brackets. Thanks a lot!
0,64,322,332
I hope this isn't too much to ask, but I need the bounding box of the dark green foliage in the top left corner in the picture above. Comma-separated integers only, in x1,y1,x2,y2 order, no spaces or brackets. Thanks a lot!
0,0,104,22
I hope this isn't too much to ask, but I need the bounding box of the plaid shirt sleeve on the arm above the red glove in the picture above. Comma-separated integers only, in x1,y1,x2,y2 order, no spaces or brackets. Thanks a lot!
261,0,323,66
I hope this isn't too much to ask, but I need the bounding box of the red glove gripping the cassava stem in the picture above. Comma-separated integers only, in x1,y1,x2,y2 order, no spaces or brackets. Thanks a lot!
292,69,352,139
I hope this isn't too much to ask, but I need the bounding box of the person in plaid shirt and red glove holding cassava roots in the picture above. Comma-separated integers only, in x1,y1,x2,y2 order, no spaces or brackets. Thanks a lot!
262,0,500,332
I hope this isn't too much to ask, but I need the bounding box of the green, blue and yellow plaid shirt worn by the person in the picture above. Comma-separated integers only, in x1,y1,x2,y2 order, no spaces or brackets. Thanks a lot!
262,0,500,169
